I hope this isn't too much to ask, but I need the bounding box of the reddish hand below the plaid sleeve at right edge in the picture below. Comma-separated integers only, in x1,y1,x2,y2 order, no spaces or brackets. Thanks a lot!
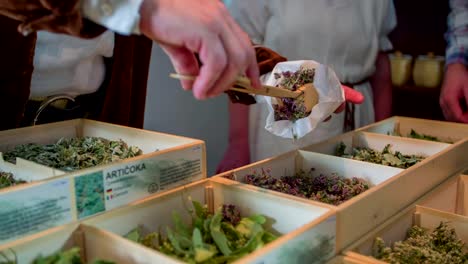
439,63,468,123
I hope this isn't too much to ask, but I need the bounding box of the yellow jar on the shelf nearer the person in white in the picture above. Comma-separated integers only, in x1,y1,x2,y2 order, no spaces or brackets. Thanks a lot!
389,51,413,86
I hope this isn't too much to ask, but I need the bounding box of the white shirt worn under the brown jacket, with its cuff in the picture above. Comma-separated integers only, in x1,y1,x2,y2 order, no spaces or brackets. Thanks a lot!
30,0,143,98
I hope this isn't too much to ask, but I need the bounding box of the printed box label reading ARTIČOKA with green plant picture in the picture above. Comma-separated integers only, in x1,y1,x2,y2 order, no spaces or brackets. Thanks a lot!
75,145,204,219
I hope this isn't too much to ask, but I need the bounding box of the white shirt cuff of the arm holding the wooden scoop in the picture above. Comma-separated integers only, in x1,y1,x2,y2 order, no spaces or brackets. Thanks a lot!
82,0,143,35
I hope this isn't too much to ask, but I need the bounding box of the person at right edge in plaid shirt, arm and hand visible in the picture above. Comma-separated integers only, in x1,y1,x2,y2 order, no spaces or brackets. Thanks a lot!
439,0,468,123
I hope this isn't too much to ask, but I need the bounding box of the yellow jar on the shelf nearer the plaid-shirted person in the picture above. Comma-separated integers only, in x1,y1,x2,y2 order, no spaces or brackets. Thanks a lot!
413,53,445,88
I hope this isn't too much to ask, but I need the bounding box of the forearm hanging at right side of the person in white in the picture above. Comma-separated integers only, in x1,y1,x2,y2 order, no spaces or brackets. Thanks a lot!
370,52,392,121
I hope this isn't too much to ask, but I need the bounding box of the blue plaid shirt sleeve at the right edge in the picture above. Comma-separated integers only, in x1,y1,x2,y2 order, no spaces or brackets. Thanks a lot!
445,0,468,66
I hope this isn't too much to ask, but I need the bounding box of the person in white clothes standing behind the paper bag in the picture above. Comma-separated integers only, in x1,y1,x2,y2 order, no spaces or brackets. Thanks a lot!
217,0,396,173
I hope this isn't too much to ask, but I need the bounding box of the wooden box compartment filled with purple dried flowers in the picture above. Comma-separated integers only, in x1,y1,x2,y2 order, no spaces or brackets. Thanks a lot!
216,150,403,250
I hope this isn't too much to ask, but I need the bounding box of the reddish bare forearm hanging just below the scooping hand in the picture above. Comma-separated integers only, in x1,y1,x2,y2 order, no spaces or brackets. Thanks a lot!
229,102,249,146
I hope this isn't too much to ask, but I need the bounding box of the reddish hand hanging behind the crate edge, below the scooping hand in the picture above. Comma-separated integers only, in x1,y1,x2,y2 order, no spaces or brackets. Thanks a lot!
216,141,250,174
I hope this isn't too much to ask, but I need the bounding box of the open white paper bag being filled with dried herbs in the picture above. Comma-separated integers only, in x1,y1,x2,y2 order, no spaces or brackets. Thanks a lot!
257,60,345,139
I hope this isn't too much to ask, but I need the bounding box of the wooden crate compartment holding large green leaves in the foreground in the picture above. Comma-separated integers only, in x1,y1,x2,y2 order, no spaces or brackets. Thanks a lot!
84,179,336,263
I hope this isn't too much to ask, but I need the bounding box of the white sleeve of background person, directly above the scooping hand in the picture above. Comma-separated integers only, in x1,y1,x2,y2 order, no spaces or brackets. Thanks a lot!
225,0,270,44
